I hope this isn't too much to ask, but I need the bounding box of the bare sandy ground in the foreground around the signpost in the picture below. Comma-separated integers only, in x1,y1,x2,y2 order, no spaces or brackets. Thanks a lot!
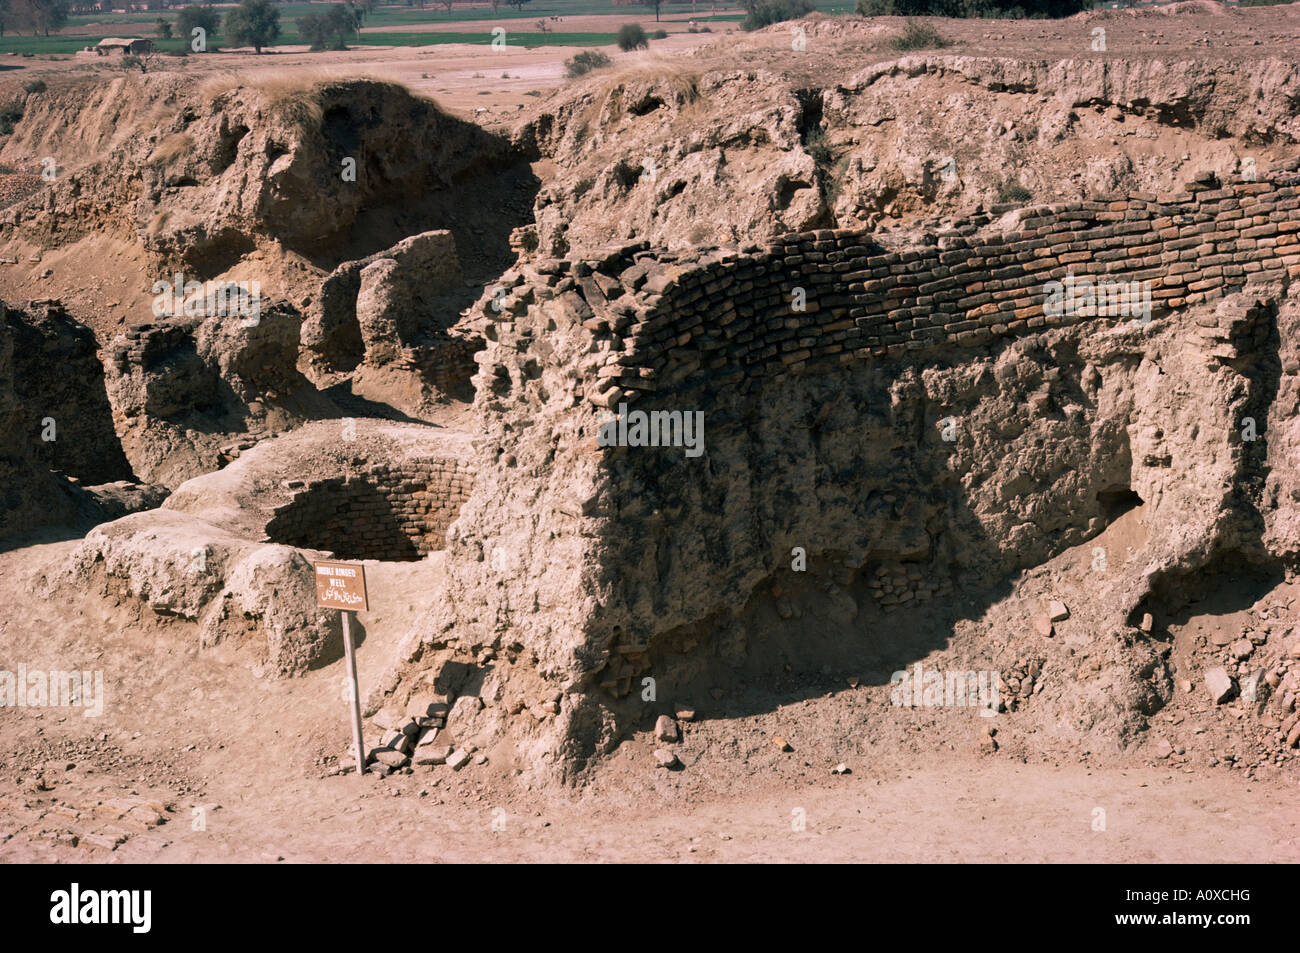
0,541,1300,863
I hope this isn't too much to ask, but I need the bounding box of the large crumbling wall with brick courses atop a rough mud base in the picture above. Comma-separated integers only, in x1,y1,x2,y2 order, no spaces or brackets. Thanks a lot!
413,177,1300,771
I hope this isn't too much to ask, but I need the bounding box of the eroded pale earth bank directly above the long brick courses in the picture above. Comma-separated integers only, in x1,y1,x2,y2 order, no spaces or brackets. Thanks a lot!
515,54,1300,256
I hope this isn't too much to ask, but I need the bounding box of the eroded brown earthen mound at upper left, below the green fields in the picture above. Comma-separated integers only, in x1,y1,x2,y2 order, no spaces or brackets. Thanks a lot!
0,74,533,273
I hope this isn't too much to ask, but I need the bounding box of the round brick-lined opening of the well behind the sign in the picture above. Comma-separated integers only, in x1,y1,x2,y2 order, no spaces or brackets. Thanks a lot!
267,459,473,560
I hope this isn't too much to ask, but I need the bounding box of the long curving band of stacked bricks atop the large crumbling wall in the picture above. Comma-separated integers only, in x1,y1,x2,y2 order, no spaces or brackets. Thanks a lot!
605,174,1300,399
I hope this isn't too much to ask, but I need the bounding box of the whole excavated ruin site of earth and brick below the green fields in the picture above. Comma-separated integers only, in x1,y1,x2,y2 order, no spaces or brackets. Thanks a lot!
0,0,1300,863
